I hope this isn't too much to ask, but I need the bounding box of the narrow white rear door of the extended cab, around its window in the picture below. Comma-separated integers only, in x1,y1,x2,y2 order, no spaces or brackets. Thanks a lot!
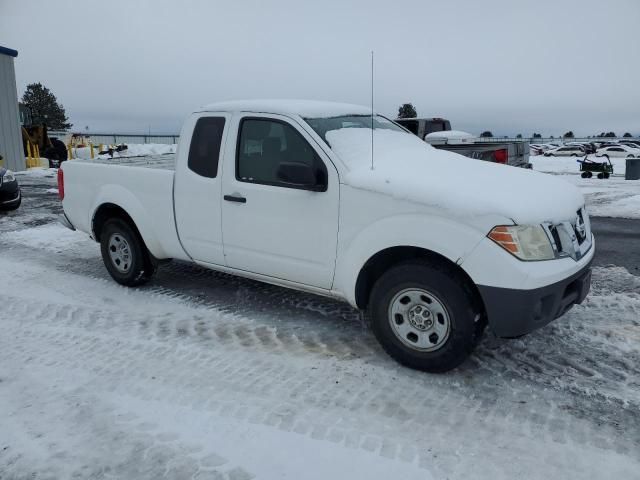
173,112,231,265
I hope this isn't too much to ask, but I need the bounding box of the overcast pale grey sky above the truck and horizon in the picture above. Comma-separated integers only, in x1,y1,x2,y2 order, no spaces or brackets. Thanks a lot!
0,0,640,135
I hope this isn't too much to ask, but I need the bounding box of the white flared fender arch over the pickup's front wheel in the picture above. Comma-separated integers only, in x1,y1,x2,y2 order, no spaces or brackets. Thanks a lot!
333,214,485,306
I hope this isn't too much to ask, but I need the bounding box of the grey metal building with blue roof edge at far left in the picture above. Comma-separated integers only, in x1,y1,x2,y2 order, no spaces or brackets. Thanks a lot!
0,46,26,171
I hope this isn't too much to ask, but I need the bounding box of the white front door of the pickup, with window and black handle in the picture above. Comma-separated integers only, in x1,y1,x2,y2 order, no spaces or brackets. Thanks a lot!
222,114,339,289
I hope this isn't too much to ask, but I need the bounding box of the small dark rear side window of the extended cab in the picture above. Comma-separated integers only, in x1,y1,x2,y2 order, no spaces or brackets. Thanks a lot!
187,117,224,178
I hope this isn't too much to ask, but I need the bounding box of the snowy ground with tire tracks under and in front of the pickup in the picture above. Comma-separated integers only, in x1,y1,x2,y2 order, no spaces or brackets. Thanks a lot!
0,171,640,480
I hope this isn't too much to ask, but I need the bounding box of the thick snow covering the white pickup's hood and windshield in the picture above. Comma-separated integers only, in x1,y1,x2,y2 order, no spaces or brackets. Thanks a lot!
326,128,584,224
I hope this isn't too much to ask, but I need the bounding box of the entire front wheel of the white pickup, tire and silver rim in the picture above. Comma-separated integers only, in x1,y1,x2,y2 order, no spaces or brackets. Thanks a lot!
369,261,486,372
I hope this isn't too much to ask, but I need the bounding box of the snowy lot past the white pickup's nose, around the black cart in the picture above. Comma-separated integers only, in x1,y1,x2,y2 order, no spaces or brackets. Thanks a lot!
530,155,640,219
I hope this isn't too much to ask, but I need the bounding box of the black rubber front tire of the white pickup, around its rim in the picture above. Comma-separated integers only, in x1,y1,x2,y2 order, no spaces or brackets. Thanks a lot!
368,260,486,373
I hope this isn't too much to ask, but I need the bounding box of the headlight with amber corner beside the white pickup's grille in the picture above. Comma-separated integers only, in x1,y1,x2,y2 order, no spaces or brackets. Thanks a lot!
488,225,556,260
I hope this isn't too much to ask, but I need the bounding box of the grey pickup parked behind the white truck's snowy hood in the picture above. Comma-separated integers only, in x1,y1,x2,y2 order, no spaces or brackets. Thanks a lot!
395,117,531,168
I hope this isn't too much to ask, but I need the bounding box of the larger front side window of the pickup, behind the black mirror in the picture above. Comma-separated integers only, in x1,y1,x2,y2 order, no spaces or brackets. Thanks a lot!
236,118,327,188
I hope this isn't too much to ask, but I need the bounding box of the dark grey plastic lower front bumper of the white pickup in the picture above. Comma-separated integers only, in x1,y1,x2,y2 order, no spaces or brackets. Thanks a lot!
478,261,591,337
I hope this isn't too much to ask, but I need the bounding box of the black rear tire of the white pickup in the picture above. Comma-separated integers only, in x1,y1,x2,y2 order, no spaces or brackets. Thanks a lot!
100,218,156,287
